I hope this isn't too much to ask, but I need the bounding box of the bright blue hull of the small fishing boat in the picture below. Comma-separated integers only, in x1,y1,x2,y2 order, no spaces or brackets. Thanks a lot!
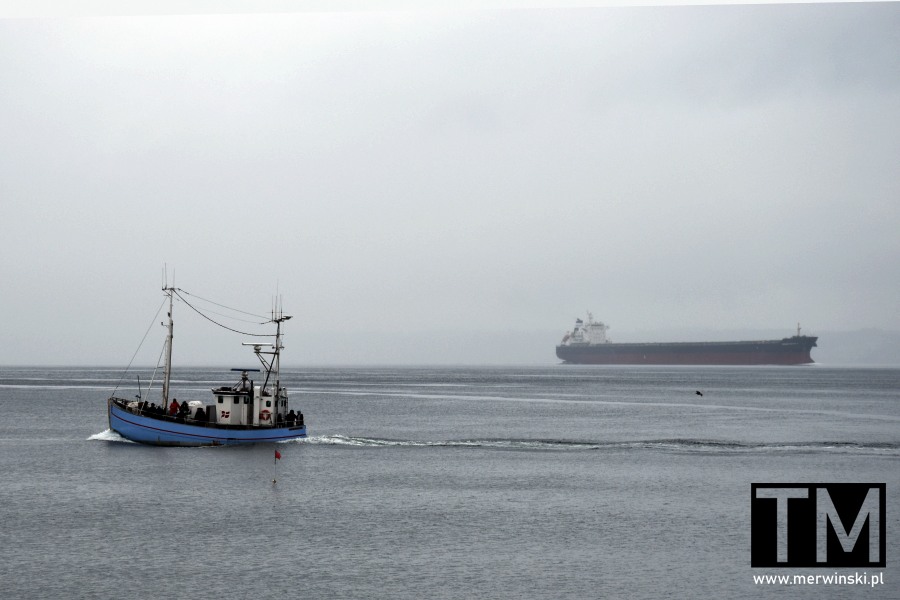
108,399,306,446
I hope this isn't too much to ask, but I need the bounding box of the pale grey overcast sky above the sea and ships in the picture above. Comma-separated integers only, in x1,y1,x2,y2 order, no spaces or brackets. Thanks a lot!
0,3,900,364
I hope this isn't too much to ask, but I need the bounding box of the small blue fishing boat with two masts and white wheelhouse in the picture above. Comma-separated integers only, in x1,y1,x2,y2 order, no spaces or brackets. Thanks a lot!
106,286,306,446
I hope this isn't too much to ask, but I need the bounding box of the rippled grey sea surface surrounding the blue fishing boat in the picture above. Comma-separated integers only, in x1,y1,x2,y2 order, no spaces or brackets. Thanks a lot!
0,366,900,599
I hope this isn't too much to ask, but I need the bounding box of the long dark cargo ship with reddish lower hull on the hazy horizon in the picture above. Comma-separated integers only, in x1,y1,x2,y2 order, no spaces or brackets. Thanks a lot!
556,313,819,365
